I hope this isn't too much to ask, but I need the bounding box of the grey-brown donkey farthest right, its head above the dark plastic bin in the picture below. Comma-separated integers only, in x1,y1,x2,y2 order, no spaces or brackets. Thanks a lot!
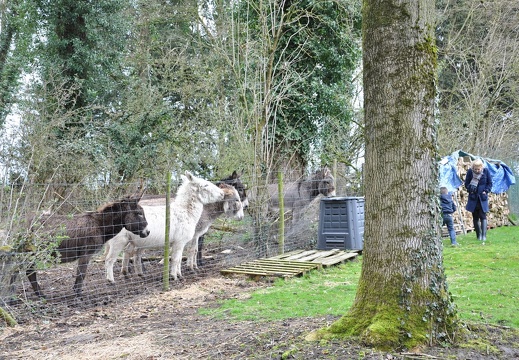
268,167,335,218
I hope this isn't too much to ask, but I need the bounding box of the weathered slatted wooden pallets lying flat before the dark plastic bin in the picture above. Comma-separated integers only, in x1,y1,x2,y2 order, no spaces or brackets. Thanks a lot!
220,249,358,278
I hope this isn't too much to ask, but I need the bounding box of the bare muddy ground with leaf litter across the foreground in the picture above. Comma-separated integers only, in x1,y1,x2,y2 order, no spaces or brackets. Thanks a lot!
0,256,519,360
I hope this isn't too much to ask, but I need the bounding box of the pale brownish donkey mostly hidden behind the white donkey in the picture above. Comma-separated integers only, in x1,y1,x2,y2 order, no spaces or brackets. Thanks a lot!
119,183,244,276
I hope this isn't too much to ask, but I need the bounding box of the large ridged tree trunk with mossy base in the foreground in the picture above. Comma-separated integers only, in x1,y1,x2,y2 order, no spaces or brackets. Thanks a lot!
308,0,457,349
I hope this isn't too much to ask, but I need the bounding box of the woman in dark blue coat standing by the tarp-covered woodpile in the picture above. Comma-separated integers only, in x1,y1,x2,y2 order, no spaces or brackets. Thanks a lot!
465,159,492,241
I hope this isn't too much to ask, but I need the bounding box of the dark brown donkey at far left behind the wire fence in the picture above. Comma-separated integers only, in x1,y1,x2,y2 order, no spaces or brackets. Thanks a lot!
26,194,150,298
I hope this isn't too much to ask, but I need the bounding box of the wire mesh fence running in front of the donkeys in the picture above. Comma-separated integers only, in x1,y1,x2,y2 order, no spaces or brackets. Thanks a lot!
0,168,359,322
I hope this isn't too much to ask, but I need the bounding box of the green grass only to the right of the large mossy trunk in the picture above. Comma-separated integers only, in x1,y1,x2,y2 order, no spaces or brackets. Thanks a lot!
444,227,519,328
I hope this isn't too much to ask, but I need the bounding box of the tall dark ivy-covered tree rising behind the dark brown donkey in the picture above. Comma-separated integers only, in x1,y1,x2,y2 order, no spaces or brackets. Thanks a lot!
20,0,132,183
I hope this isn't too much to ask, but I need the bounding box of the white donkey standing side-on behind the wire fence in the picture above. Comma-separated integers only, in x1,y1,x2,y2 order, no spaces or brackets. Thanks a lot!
105,171,224,283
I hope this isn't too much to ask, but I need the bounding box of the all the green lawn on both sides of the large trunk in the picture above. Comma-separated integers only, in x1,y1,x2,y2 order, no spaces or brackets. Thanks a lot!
201,227,519,328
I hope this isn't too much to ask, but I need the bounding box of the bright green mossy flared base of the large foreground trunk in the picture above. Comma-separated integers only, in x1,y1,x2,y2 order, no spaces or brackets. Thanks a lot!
313,272,457,350
